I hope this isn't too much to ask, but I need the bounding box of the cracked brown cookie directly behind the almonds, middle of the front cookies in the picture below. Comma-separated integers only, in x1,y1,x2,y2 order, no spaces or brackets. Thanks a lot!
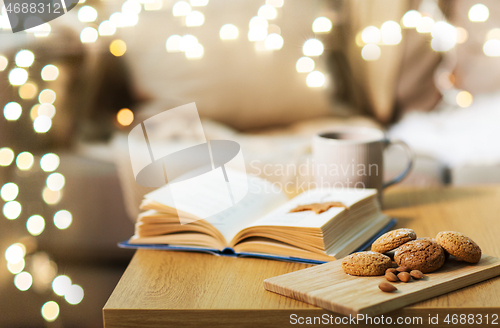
394,239,445,273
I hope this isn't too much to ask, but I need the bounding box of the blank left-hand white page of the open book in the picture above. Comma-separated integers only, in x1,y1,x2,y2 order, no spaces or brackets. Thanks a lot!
145,169,287,242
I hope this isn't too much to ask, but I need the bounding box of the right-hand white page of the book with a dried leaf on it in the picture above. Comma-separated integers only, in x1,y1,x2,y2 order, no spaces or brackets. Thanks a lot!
250,188,377,228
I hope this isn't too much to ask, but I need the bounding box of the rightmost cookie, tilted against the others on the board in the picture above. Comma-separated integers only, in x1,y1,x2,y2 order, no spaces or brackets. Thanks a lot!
436,231,481,263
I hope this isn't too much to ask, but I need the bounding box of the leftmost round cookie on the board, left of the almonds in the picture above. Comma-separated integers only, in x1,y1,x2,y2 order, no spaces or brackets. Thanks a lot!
342,252,392,276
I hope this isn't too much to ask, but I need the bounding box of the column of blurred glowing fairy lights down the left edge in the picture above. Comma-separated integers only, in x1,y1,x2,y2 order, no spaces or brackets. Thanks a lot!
0,50,84,322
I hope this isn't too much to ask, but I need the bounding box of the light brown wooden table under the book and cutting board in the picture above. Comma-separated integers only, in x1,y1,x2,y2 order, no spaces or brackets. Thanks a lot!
103,186,500,328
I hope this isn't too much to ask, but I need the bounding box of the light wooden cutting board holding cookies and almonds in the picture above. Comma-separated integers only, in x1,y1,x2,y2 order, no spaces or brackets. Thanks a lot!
264,255,500,316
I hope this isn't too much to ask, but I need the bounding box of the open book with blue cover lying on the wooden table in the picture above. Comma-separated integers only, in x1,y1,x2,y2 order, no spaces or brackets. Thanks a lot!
120,172,394,263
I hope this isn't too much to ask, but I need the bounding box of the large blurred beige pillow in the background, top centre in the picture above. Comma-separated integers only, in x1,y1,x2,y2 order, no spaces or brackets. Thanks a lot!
116,0,330,129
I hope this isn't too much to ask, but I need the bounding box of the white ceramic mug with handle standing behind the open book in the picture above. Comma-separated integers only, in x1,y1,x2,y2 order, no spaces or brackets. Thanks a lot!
312,127,413,203
